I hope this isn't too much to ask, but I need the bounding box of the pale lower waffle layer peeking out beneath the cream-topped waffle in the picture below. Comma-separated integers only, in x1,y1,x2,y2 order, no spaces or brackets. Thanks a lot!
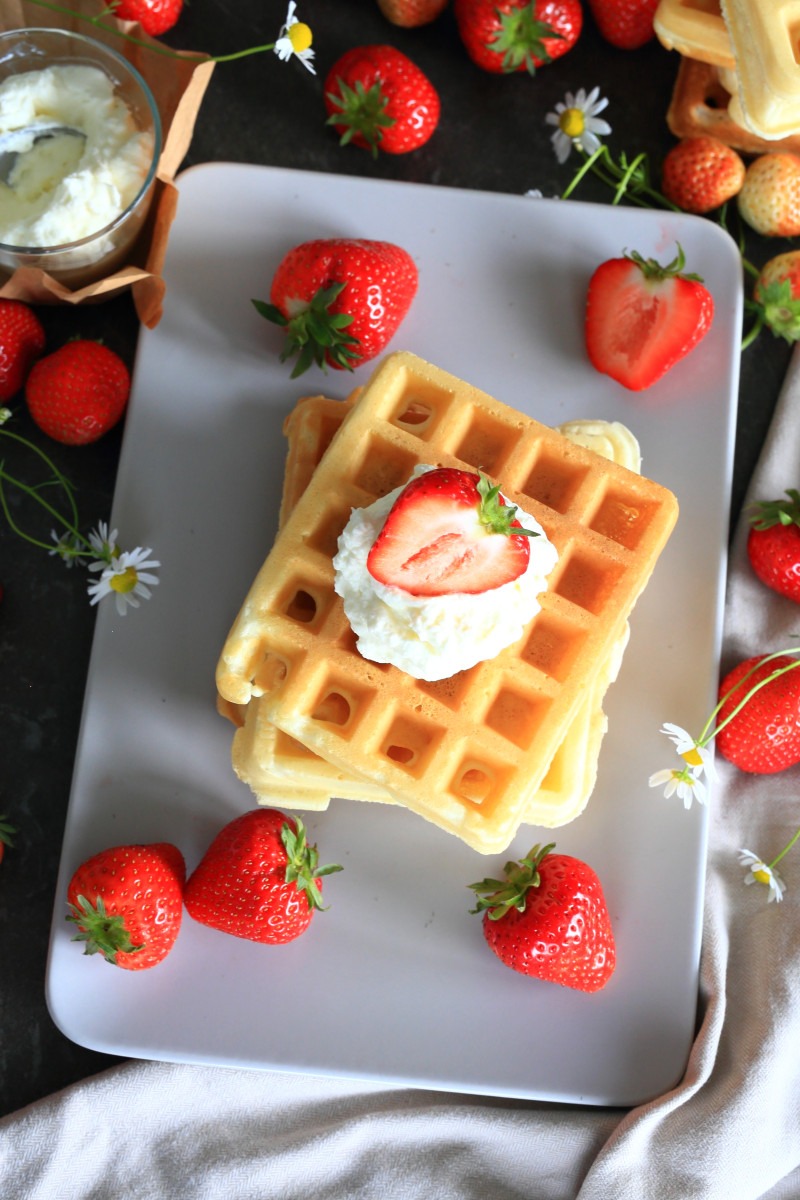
231,396,640,828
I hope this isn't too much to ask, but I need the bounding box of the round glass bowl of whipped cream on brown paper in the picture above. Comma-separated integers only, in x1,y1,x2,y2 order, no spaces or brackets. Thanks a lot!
0,29,162,288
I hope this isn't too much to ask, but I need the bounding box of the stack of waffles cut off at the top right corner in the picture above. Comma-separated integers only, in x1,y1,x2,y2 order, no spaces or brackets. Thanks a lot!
654,0,800,154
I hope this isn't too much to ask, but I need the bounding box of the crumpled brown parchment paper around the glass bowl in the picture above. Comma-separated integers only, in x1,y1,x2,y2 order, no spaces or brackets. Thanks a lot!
0,0,213,329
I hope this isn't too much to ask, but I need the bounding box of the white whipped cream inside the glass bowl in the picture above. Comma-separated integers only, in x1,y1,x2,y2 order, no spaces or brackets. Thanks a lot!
0,64,154,248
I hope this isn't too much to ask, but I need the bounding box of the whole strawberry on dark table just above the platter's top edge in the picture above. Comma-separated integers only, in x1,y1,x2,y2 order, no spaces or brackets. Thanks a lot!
324,46,441,156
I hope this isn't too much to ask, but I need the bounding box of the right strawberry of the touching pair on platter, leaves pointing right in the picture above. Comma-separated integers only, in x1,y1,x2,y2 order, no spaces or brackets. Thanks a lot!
184,809,342,946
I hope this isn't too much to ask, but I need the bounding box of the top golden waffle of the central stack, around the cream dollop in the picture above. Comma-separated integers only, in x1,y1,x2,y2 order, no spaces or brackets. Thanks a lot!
217,353,678,853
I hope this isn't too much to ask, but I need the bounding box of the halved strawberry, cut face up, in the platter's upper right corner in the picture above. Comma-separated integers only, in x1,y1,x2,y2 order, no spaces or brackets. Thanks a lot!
584,246,714,391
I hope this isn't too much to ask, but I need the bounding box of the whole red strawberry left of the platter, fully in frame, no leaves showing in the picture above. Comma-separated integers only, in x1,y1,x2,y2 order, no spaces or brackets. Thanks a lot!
25,338,131,445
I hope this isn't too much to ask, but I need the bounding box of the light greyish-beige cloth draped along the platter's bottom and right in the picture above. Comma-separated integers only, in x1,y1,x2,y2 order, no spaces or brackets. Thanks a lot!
0,349,800,1200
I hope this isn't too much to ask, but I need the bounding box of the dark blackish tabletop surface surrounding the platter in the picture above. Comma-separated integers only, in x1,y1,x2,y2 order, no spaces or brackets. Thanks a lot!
0,0,792,1115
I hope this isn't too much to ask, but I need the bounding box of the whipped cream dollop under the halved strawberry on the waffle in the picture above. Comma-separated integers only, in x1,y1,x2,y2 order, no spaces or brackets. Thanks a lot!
333,466,558,682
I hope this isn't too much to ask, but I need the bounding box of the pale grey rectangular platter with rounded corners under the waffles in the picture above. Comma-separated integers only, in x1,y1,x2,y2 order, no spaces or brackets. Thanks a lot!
47,163,741,1105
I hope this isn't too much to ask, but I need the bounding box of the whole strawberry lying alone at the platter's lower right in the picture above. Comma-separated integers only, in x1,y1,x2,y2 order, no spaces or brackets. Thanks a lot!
470,844,616,992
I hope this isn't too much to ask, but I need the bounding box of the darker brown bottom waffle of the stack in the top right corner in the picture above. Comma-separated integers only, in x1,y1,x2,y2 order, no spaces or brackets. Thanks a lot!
667,59,800,154
